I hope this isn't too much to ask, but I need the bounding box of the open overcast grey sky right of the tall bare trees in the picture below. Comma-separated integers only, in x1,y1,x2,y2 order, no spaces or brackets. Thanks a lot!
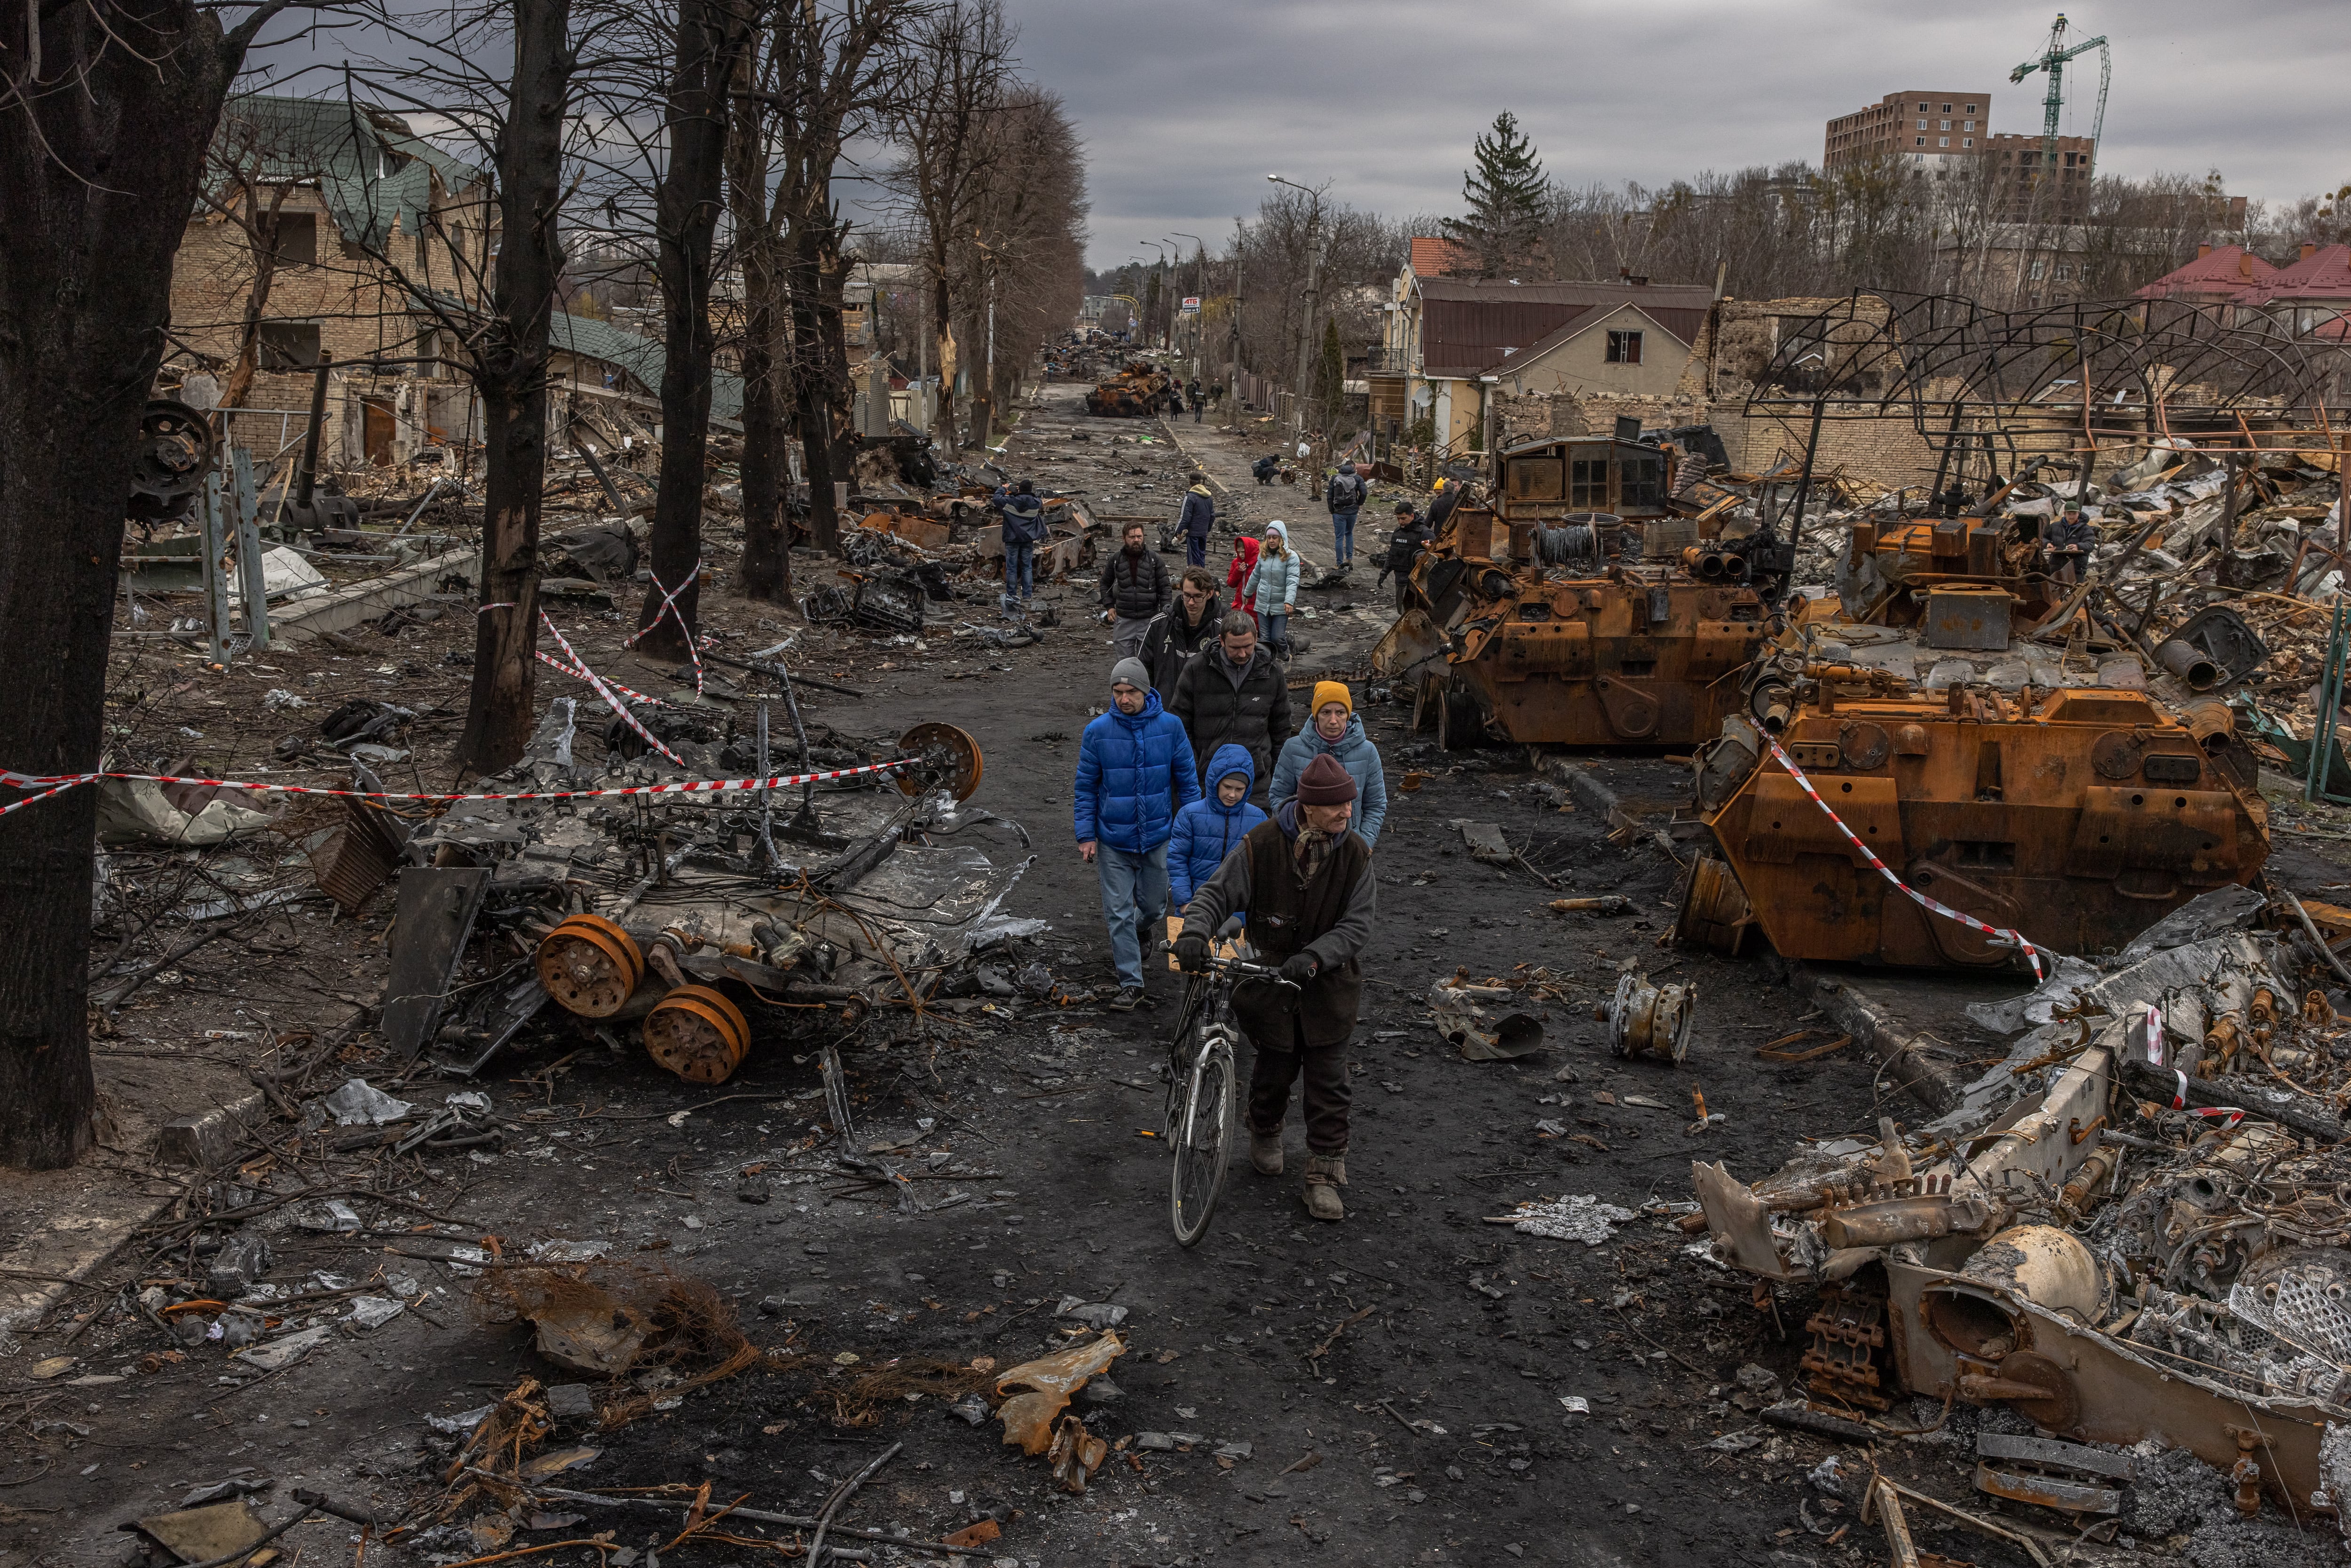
1006,0,2351,268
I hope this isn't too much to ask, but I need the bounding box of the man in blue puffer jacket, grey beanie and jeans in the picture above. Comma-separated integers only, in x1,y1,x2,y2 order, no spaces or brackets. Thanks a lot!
1074,658,1199,1013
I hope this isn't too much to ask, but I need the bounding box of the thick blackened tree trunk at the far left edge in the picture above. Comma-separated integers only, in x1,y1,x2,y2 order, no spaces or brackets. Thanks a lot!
0,0,259,1168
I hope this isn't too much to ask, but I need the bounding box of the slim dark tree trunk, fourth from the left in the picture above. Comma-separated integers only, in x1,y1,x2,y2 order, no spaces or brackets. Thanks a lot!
726,47,792,604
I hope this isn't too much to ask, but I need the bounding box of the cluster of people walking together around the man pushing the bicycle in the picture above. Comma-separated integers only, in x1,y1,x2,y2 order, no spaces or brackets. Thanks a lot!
1072,524,1387,1220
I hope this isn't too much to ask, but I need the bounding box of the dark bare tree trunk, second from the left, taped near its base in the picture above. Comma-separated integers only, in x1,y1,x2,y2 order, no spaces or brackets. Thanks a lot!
456,0,574,773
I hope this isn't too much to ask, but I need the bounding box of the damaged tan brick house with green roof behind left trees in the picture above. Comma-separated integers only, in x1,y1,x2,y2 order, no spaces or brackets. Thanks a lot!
162,94,741,468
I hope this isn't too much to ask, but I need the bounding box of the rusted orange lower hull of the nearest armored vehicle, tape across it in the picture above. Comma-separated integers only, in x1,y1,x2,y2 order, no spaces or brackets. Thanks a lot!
1704,689,2269,969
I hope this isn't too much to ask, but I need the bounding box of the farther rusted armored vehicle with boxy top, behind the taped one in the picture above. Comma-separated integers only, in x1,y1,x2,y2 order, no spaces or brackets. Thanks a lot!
1373,437,1791,748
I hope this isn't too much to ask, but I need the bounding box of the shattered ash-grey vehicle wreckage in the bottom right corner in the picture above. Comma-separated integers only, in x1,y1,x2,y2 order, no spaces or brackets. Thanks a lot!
1683,889,2351,1523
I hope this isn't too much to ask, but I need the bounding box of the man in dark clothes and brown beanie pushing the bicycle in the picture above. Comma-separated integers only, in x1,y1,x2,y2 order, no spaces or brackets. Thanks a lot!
1176,757,1378,1220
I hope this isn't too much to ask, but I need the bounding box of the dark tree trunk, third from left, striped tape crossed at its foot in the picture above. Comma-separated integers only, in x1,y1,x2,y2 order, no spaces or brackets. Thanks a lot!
637,0,743,658
